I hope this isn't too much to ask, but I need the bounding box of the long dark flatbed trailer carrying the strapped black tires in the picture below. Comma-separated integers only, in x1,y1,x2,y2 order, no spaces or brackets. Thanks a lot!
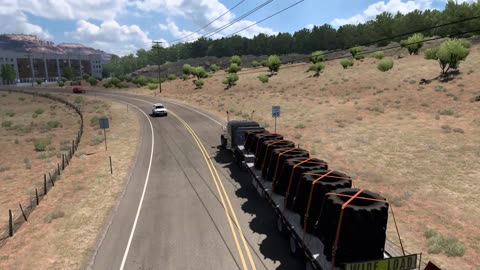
231,145,421,270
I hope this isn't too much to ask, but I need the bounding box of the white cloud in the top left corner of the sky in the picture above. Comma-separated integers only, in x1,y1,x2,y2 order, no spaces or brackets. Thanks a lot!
0,0,52,39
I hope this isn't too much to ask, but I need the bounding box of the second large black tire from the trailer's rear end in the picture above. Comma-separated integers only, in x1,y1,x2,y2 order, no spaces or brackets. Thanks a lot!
290,170,352,233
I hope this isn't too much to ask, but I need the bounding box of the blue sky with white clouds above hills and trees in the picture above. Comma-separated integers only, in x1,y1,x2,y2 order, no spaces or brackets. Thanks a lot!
0,0,475,56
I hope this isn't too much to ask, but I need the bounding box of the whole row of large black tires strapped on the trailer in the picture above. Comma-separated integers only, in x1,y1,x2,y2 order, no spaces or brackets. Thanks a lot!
245,130,388,266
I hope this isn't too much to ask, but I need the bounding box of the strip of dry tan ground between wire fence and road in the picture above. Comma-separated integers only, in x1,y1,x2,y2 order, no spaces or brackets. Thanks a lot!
0,95,139,269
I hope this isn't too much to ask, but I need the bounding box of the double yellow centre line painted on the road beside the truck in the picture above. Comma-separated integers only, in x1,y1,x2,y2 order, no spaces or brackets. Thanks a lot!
170,111,257,270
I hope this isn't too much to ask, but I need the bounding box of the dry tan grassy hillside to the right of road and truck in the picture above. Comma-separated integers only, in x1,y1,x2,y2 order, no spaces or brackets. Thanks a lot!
100,47,480,269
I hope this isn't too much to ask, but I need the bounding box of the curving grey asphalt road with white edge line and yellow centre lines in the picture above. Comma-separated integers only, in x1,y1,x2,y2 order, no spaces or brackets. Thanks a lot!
69,92,304,270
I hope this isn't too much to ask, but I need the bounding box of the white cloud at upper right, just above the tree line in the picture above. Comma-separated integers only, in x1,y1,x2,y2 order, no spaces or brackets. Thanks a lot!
332,0,436,26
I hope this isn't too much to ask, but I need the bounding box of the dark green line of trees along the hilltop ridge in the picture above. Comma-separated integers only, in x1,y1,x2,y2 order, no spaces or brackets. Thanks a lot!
104,0,480,76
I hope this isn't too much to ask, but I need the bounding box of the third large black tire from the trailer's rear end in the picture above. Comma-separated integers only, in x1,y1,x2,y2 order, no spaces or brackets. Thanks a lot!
273,157,328,199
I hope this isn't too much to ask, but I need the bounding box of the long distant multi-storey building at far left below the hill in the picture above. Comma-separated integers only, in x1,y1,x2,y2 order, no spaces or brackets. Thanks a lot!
0,49,104,85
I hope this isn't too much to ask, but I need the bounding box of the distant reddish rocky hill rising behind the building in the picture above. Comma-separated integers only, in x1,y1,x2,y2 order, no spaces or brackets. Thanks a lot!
0,34,112,58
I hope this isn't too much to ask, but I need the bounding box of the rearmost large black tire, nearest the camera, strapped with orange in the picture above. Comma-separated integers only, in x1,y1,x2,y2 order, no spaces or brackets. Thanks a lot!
316,188,388,265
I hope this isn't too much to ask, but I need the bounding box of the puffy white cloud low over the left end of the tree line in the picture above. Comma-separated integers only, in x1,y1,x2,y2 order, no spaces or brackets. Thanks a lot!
65,20,156,55
